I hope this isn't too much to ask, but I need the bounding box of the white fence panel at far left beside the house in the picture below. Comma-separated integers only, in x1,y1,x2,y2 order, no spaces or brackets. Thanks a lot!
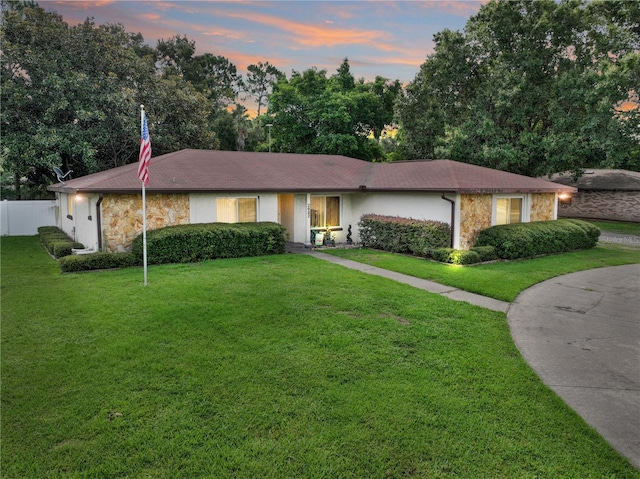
0,200,58,236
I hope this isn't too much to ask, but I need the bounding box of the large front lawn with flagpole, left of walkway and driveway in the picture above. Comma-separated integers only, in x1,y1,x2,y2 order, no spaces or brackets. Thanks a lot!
0,237,640,479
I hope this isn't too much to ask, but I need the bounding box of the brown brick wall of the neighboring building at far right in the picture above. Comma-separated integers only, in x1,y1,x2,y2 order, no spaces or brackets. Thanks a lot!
558,191,640,223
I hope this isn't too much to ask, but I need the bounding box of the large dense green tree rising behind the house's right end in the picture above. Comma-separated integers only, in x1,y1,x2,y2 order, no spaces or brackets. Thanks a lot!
398,0,639,176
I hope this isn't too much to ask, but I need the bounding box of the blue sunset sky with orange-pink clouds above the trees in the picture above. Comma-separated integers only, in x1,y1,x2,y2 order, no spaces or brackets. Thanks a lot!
38,0,484,83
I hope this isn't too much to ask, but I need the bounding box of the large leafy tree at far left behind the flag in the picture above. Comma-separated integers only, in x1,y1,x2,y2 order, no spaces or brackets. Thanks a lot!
0,2,216,197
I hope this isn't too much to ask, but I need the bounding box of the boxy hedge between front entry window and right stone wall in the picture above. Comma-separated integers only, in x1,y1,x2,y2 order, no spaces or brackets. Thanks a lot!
358,214,451,256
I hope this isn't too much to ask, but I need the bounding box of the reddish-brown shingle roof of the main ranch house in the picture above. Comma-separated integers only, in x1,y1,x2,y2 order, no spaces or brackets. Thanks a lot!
49,150,575,193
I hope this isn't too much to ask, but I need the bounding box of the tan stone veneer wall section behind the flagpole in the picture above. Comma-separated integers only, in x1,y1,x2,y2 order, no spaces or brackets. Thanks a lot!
100,194,189,253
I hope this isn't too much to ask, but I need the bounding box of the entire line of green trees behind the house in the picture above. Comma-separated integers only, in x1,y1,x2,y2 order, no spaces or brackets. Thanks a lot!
0,0,640,198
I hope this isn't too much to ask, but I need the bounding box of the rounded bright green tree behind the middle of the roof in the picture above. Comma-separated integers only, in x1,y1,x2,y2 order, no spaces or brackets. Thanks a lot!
269,59,400,161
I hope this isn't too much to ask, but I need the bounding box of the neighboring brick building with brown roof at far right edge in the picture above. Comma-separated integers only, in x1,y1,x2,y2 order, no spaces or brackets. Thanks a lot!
551,169,640,222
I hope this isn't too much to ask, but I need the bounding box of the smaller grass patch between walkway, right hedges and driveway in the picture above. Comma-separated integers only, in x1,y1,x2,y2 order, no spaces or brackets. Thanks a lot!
324,244,640,302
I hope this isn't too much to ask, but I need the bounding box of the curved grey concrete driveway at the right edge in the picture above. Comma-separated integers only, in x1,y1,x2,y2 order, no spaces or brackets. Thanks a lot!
507,264,640,467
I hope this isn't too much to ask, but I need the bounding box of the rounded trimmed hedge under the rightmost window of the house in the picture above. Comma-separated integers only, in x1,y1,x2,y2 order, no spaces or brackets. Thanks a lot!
476,219,600,259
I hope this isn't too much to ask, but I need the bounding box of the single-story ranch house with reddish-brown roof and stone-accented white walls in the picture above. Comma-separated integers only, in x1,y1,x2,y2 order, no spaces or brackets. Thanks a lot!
49,150,575,252
